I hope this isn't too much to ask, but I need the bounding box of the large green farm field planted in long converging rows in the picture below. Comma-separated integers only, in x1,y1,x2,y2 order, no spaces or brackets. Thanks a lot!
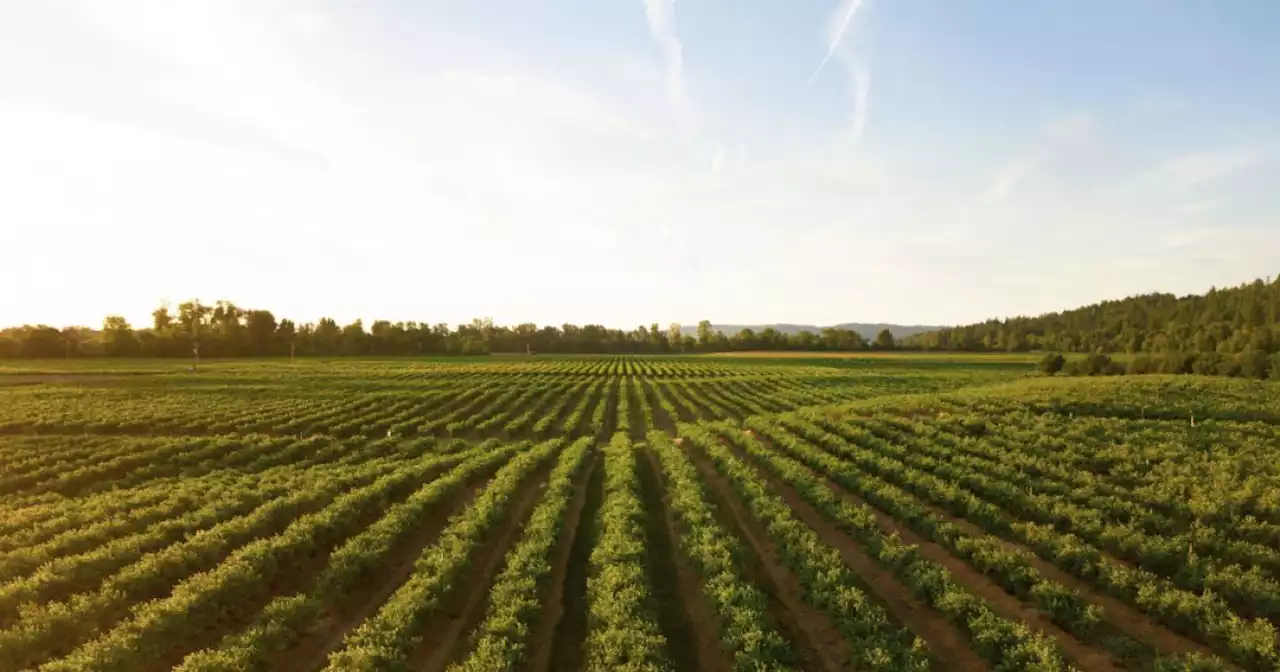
0,353,1280,672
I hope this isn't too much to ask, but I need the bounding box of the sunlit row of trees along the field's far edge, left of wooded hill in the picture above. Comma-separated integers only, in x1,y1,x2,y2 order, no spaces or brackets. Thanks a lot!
0,301,895,357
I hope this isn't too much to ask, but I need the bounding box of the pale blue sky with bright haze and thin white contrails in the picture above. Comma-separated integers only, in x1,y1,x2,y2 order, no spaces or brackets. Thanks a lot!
0,0,1280,328
